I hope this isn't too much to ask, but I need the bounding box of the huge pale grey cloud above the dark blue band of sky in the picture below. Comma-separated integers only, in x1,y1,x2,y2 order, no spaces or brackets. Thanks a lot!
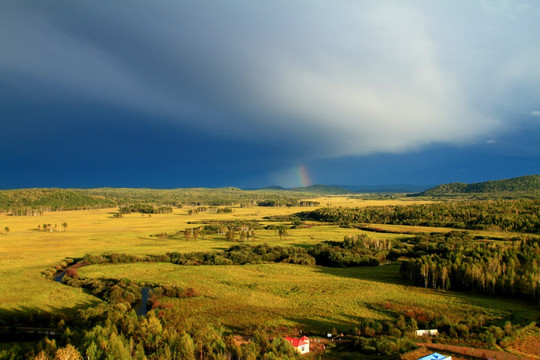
0,0,540,157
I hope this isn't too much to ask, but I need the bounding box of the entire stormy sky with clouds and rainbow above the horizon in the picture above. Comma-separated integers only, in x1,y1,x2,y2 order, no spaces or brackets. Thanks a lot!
0,0,540,188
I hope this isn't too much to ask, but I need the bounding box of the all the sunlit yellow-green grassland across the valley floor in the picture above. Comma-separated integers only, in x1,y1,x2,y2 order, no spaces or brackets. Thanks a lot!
0,197,539,329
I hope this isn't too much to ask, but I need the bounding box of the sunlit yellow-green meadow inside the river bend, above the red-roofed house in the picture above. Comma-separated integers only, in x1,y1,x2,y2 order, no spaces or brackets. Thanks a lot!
79,263,539,331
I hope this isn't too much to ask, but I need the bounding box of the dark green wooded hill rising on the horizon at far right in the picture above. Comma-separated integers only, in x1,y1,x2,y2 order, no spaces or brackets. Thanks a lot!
418,175,540,196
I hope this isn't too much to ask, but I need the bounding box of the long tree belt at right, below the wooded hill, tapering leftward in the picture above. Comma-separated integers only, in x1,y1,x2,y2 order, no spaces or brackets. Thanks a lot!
304,199,540,233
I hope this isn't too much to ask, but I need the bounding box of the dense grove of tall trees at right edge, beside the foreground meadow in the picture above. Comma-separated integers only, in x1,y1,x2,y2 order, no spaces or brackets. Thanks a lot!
400,238,540,300
